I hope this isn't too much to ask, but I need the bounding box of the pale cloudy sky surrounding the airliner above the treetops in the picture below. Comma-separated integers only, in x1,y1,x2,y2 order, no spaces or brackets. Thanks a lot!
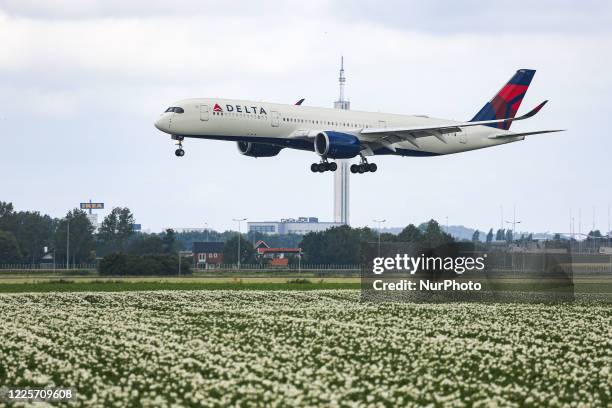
0,0,612,232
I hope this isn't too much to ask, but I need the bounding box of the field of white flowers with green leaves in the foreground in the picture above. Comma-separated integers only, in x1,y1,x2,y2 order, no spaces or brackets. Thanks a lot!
0,290,612,407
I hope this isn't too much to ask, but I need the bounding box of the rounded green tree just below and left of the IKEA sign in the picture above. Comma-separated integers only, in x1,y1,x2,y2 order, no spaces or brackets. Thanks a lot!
54,208,95,265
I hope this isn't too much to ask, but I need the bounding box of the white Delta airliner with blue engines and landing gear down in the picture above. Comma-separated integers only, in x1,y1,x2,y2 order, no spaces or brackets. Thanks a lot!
155,69,562,174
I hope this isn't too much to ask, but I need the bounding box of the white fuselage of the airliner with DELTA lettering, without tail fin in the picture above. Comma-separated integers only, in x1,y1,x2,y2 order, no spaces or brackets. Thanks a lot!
155,98,523,156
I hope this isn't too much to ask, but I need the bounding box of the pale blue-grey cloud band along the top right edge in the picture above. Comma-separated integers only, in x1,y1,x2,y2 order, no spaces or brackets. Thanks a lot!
333,0,612,33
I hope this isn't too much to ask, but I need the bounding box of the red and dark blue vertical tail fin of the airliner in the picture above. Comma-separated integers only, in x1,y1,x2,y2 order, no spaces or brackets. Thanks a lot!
470,69,535,130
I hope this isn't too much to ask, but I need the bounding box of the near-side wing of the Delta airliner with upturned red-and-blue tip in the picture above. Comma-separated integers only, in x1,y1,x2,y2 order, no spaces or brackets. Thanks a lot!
360,101,548,150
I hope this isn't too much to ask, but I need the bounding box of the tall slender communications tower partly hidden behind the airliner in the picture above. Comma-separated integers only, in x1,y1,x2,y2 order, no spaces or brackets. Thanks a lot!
334,56,351,225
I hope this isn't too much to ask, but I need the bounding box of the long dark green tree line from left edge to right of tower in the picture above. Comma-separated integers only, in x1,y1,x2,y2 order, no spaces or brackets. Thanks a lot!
0,202,453,266
